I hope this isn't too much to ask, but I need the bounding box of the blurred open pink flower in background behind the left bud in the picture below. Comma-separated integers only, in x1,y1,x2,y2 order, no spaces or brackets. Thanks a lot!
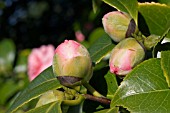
28,45,54,81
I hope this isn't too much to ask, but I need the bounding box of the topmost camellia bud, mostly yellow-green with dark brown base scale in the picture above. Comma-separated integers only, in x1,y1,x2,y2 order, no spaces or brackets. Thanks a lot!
102,11,138,42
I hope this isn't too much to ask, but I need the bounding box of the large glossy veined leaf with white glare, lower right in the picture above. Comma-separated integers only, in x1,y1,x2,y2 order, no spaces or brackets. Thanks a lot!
111,59,170,113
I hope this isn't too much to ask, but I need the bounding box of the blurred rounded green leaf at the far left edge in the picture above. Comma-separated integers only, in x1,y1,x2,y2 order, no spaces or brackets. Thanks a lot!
0,39,15,74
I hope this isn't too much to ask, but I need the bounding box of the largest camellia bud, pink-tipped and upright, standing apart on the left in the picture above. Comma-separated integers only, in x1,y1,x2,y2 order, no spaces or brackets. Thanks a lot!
53,40,92,86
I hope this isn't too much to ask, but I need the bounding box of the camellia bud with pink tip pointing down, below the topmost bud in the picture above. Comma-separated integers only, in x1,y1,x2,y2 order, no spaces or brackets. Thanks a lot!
109,38,145,75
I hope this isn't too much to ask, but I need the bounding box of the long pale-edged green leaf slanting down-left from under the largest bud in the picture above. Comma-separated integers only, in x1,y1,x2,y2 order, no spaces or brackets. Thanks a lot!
7,67,61,113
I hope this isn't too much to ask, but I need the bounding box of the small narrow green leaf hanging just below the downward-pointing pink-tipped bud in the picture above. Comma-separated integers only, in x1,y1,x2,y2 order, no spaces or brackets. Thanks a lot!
104,71,118,99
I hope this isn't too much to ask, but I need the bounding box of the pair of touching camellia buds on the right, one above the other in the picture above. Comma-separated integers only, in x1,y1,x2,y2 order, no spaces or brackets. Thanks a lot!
102,11,145,76
